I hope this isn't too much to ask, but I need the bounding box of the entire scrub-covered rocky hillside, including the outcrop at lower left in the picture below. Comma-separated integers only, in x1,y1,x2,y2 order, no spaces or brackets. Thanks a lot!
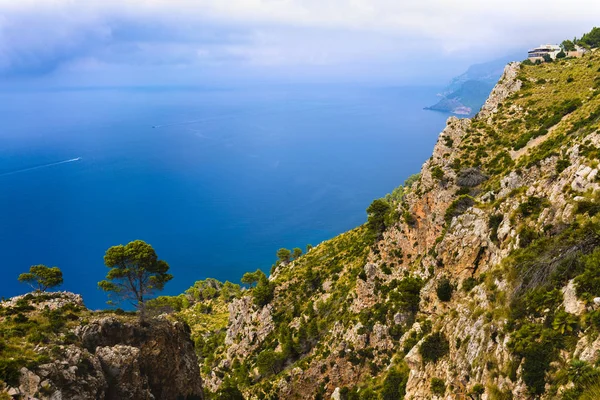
0,52,600,400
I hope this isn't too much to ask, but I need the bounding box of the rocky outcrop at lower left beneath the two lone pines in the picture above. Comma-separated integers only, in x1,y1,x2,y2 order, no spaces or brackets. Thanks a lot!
2,293,203,400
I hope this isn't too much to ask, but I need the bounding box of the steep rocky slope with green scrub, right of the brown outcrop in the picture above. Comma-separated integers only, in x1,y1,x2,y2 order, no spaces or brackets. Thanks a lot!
180,53,600,399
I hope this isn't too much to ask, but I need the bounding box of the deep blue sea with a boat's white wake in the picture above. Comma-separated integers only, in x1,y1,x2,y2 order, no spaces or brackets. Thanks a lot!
0,85,446,308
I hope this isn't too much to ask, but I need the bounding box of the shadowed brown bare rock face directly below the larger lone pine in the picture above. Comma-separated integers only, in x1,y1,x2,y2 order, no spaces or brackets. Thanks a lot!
77,317,202,400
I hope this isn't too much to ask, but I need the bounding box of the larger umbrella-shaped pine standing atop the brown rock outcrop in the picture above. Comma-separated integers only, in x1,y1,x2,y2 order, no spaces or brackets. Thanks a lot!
98,240,173,318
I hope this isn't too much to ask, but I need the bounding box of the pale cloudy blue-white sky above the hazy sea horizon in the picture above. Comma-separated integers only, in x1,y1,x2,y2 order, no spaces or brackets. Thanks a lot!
0,0,600,87
